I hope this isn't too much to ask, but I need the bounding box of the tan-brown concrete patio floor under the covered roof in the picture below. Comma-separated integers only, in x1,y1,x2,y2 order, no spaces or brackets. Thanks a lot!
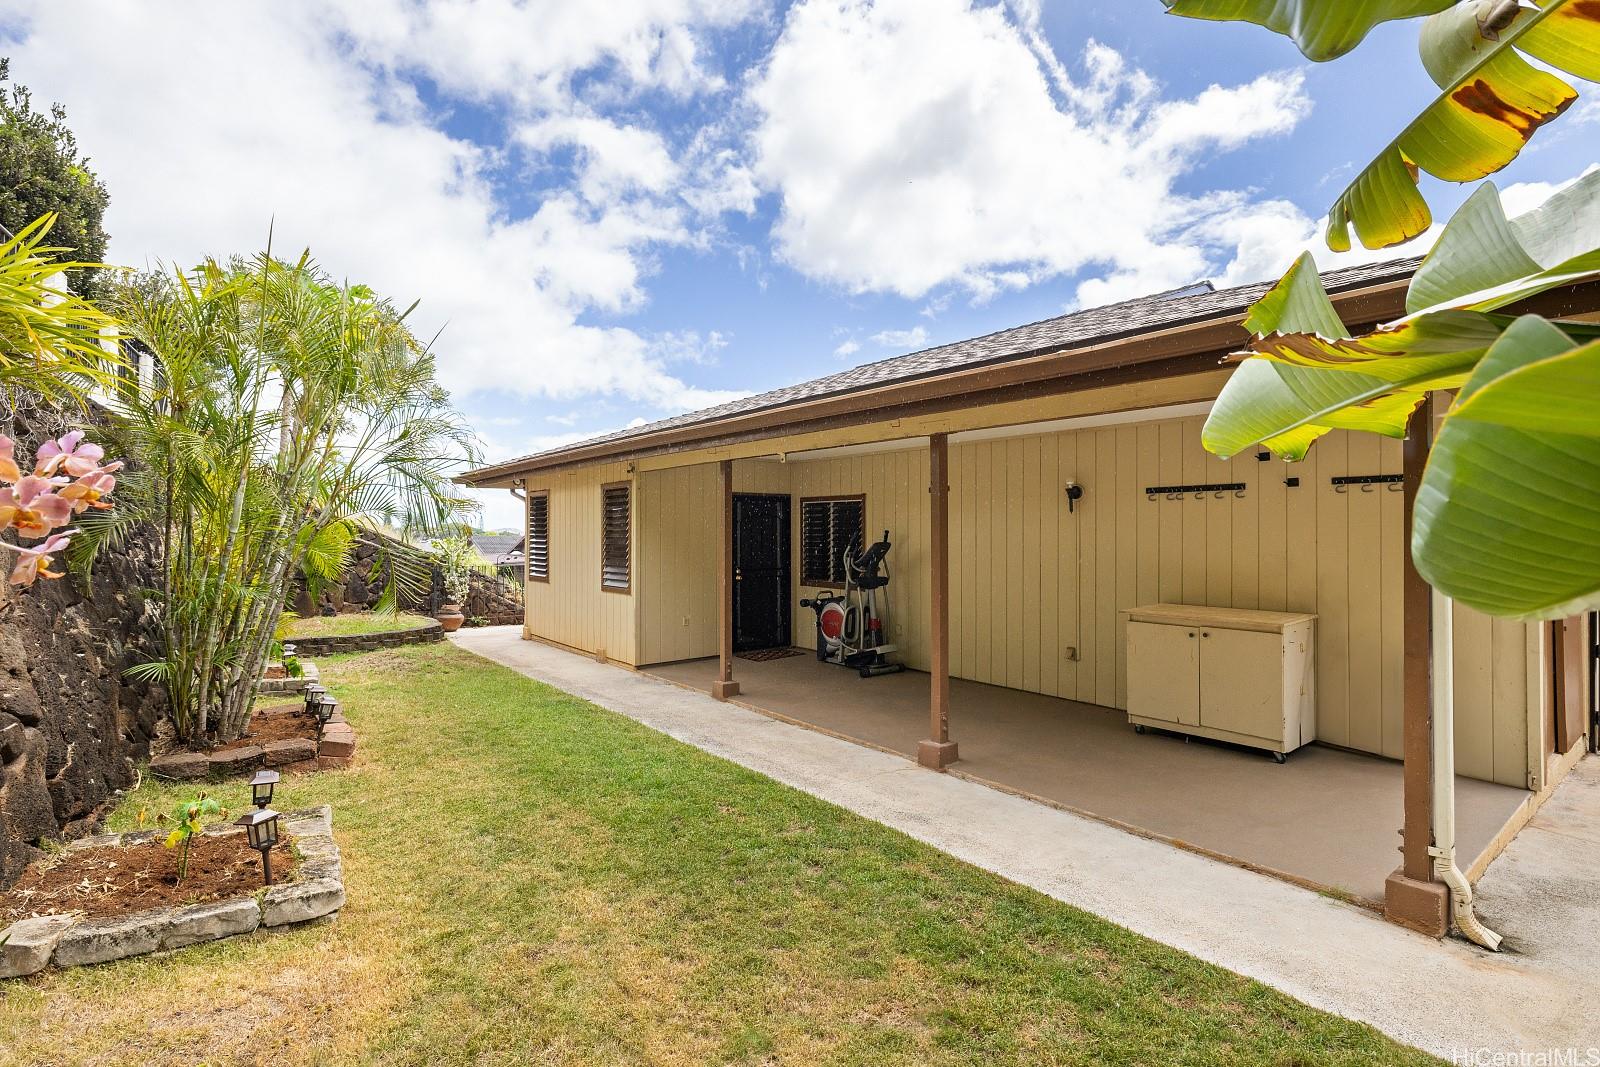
646,654,1528,907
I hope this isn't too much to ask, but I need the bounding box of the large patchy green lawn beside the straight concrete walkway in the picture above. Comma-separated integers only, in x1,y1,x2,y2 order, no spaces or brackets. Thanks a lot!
0,645,1432,1065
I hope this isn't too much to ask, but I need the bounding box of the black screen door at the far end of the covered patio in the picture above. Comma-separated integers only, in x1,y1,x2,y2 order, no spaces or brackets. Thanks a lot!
733,493,789,653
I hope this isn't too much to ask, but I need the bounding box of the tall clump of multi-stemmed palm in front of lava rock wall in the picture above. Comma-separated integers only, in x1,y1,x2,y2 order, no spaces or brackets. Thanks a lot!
85,253,475,742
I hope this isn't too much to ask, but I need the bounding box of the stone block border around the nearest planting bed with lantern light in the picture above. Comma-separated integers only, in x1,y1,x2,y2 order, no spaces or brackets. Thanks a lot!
0,805,344,977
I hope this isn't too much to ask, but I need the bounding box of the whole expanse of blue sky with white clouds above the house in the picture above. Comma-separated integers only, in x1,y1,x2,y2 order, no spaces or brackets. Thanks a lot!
0,0,1600,525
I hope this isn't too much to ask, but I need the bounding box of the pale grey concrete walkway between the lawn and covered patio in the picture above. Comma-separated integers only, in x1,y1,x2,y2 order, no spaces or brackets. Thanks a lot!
453,627,1600,1062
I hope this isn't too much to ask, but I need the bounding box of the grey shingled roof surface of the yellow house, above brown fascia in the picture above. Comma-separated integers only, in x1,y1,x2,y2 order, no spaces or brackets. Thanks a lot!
461,258,1421,483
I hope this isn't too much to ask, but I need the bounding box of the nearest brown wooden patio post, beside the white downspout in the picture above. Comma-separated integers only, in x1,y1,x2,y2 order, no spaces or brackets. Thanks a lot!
1384,395,1450,937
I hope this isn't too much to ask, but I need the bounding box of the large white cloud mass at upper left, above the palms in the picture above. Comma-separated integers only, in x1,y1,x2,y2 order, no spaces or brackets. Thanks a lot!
0,0,752,410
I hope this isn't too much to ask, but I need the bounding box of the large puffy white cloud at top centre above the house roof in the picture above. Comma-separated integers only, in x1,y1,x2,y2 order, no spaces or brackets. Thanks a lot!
749,0,1309,299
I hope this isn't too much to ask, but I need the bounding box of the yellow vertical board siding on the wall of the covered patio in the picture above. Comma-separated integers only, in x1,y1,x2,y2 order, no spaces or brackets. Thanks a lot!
608,418,1538,785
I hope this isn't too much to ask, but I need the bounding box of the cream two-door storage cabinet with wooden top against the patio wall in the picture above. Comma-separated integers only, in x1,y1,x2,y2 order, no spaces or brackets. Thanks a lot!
1125,605,1317,763
